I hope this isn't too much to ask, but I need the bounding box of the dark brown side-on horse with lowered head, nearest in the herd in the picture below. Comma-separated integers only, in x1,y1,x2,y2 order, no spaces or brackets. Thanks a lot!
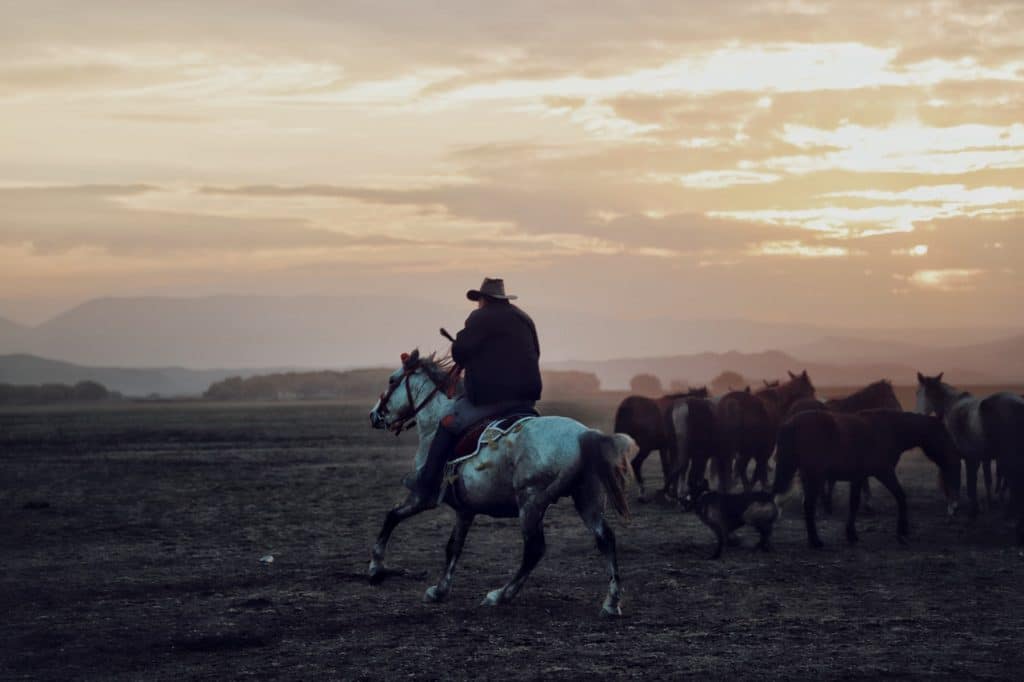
772,410,959,548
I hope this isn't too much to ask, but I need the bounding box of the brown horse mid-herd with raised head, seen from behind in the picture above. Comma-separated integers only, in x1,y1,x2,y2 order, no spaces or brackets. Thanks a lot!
716,370,814,491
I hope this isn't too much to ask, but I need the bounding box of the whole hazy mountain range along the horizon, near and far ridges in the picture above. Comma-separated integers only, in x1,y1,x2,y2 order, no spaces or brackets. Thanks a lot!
0,296,1024,394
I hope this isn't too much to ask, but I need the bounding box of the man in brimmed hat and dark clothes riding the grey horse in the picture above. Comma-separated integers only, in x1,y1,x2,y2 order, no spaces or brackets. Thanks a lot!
411,279,542,507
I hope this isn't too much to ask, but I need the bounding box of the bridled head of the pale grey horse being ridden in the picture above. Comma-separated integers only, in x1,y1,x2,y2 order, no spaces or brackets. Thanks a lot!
370,349,455,434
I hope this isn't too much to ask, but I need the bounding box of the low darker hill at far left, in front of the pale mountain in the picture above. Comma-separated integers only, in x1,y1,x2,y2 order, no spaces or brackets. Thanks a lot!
0,354,292,396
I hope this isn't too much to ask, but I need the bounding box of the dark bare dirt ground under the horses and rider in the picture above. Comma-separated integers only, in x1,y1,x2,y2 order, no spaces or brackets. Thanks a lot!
0,399,1024,680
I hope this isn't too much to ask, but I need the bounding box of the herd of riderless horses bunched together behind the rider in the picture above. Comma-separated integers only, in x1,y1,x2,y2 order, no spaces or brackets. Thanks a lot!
614,371,1024,547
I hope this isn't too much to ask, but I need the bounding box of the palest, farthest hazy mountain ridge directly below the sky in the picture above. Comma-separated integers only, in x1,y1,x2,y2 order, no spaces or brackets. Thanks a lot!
0,296,1021,369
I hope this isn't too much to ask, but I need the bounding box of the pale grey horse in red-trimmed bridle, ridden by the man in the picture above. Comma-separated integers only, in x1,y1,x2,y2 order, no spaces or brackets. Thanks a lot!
370,350,636,615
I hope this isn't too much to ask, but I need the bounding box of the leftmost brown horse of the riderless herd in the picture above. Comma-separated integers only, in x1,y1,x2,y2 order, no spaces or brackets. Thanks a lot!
614,388,708,502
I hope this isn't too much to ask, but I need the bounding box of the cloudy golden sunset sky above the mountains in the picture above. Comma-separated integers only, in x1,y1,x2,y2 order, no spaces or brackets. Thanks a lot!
0,0,1024,327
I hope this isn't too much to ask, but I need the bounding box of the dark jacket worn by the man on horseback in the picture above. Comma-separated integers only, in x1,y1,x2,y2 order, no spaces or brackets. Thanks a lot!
452,302,541,404
